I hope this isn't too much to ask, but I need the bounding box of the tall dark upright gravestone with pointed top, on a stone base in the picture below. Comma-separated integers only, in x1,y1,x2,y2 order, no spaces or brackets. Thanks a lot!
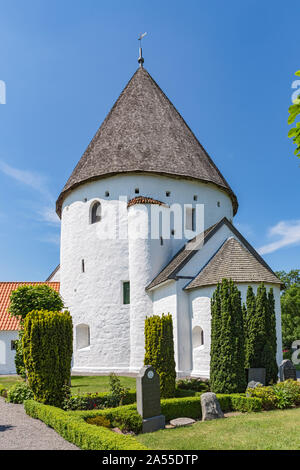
136,366,165,432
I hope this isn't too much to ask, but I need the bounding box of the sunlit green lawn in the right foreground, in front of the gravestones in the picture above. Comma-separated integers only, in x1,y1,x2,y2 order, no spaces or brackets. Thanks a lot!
137,408,300,450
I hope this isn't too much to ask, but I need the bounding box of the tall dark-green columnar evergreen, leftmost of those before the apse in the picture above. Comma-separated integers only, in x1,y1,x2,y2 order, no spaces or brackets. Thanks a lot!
210,279,247,393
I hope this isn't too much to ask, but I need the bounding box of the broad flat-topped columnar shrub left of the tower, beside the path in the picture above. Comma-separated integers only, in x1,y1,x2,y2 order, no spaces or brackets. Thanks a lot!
23,310,73,406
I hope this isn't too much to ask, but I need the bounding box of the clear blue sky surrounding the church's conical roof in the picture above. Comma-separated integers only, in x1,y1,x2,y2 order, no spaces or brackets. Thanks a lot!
0,0,300,281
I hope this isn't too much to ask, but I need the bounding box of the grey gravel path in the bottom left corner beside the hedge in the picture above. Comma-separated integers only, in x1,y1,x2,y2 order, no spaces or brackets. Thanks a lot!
0,397,79,450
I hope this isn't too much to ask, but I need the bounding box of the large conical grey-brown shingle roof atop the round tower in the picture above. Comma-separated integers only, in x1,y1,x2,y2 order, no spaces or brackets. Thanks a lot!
57,67,238,215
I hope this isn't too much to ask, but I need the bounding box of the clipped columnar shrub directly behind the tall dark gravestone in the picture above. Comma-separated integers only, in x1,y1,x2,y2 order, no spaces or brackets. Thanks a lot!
144,314,176,398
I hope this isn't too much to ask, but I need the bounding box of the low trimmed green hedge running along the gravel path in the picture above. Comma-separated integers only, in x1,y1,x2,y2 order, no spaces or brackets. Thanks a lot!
24,400,147,450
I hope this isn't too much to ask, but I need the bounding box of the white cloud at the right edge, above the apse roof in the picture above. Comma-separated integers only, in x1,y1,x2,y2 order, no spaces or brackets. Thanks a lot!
258,220,300,255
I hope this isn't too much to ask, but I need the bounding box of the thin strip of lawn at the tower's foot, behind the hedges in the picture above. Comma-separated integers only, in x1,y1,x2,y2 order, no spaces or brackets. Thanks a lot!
0,375,136,395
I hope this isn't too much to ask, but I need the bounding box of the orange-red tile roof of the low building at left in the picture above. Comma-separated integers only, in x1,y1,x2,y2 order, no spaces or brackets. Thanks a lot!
0,282,60,331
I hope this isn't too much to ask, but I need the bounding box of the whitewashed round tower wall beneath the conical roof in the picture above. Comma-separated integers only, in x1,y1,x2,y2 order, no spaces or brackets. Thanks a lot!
60,174,232,372
